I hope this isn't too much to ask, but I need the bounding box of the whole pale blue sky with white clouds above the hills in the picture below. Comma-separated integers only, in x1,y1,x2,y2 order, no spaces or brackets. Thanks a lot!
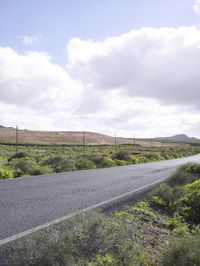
0,0,200,137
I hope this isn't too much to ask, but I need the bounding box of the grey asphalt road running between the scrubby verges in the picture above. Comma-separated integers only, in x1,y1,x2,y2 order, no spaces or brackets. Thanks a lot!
0,154,200,240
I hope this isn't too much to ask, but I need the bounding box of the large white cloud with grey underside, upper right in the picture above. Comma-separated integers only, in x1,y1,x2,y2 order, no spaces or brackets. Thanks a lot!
68,27,200,106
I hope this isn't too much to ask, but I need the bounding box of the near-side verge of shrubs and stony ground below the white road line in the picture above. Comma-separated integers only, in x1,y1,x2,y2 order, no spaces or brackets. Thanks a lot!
0,164,200,266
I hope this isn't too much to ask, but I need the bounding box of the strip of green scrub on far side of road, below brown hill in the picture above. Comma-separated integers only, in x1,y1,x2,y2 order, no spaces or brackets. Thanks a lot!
0,144,200,180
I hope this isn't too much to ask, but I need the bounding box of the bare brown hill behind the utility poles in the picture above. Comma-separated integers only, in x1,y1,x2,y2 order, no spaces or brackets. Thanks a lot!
0,127,177,147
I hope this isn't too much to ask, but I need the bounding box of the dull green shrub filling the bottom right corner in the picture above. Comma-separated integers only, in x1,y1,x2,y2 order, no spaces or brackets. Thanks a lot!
161,235,200,266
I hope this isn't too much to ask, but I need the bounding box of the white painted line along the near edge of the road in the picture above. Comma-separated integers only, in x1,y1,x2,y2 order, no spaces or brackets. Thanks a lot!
0,177,170,246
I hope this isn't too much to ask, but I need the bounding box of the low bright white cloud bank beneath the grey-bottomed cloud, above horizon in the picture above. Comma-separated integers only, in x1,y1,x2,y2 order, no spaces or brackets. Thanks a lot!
74,91,199,137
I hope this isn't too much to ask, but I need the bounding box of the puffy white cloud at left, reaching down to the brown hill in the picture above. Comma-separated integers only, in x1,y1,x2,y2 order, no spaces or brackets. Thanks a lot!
0,47,83,130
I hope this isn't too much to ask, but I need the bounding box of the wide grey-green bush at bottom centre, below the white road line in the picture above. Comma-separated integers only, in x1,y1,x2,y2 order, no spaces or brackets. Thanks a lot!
5,213,152,266
